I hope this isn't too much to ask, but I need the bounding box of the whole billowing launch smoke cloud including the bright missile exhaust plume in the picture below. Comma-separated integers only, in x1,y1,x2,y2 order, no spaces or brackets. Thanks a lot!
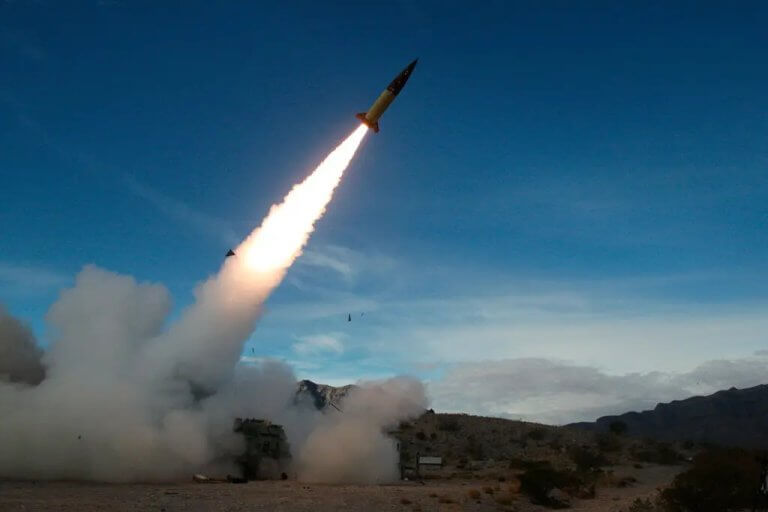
0,127,426,481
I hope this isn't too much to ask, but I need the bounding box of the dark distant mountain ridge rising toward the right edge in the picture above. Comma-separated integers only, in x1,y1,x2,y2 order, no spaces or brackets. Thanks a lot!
569,384,768,449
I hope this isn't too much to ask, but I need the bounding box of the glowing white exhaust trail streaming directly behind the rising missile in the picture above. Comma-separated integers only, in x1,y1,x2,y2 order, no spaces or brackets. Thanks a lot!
150,125,368,390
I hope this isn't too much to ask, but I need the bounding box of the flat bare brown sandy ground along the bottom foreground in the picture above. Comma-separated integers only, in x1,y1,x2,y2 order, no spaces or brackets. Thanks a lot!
0,466,680,512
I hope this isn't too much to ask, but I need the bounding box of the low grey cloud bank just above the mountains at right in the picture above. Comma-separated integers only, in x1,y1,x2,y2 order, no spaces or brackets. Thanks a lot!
429,357,768,424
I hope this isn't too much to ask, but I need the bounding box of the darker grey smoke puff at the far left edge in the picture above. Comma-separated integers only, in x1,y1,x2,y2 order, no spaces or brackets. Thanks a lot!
0,304,45,385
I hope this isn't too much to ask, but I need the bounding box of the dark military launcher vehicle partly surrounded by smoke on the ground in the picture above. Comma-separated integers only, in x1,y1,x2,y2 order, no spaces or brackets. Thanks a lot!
234,418,291,480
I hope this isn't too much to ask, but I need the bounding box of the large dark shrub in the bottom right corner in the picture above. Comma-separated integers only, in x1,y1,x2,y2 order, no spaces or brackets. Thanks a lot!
661,448,760,512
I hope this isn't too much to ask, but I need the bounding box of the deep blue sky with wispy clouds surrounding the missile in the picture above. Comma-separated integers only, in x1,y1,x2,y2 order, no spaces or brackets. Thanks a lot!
0,0,768,418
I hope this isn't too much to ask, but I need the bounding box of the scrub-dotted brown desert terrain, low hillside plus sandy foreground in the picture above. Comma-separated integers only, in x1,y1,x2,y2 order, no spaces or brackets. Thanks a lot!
0,414,757,512
